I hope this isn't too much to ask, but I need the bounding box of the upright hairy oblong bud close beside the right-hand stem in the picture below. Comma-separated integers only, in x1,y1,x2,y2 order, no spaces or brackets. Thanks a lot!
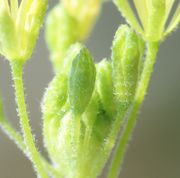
112,25,144,104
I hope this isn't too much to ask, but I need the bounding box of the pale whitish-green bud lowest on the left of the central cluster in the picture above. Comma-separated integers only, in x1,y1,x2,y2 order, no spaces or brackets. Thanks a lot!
44,109,74,177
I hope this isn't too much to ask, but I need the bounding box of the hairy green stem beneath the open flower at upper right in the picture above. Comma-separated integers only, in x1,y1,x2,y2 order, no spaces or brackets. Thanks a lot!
108,42,159,178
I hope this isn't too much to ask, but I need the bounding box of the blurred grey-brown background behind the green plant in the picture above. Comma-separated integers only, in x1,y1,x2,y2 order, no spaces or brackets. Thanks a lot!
0,0,180,178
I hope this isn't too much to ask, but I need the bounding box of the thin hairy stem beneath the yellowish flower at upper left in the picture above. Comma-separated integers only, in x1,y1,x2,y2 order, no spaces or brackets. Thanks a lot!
10,61,48,178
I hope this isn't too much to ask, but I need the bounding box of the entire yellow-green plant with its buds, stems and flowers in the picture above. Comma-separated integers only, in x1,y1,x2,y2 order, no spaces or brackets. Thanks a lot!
0,0,180,178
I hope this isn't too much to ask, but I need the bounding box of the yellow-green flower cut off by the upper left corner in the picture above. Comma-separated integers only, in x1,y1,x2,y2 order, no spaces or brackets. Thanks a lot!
0,0,47,61
